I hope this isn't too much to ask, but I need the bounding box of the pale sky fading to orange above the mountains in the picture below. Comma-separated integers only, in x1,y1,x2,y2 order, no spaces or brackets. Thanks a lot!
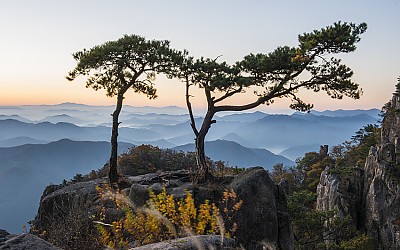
0,0,400,111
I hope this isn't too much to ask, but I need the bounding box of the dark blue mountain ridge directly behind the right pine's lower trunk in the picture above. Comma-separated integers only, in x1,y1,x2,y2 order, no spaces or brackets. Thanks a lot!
173,140,294,169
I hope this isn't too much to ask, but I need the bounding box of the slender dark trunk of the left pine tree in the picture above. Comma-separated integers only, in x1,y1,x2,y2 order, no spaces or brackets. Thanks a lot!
108,94,124,184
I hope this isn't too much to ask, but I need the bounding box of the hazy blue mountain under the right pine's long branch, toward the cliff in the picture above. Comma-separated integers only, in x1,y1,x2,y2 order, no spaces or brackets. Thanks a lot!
233,114,376,151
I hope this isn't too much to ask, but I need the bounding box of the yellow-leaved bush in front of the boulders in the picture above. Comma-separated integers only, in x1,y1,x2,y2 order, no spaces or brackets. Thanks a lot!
97,188,242,248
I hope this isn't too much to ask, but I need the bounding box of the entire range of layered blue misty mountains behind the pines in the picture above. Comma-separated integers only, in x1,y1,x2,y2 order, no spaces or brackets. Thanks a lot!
0,103,379,232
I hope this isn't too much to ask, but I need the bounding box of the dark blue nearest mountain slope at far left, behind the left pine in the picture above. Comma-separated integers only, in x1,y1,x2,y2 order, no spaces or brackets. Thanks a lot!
0,139,132,232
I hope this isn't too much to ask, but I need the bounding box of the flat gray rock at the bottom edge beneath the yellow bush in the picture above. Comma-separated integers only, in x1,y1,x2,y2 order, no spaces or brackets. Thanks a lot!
130,235,236,250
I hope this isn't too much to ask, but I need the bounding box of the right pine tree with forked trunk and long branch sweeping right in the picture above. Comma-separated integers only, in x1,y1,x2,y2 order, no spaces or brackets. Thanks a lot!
179,22,367,182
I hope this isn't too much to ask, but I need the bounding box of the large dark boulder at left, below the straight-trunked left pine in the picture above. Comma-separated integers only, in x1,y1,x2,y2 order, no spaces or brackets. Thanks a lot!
31,179,111,249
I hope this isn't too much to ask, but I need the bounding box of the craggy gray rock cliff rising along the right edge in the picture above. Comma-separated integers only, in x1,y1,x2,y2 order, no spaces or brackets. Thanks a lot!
317,82,400,249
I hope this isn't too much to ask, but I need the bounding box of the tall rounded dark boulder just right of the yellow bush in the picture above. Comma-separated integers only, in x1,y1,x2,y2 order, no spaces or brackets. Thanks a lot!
230,167,293,249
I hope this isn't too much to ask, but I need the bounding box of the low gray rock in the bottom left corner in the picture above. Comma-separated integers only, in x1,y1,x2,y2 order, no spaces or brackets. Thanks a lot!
0,229,61,250
